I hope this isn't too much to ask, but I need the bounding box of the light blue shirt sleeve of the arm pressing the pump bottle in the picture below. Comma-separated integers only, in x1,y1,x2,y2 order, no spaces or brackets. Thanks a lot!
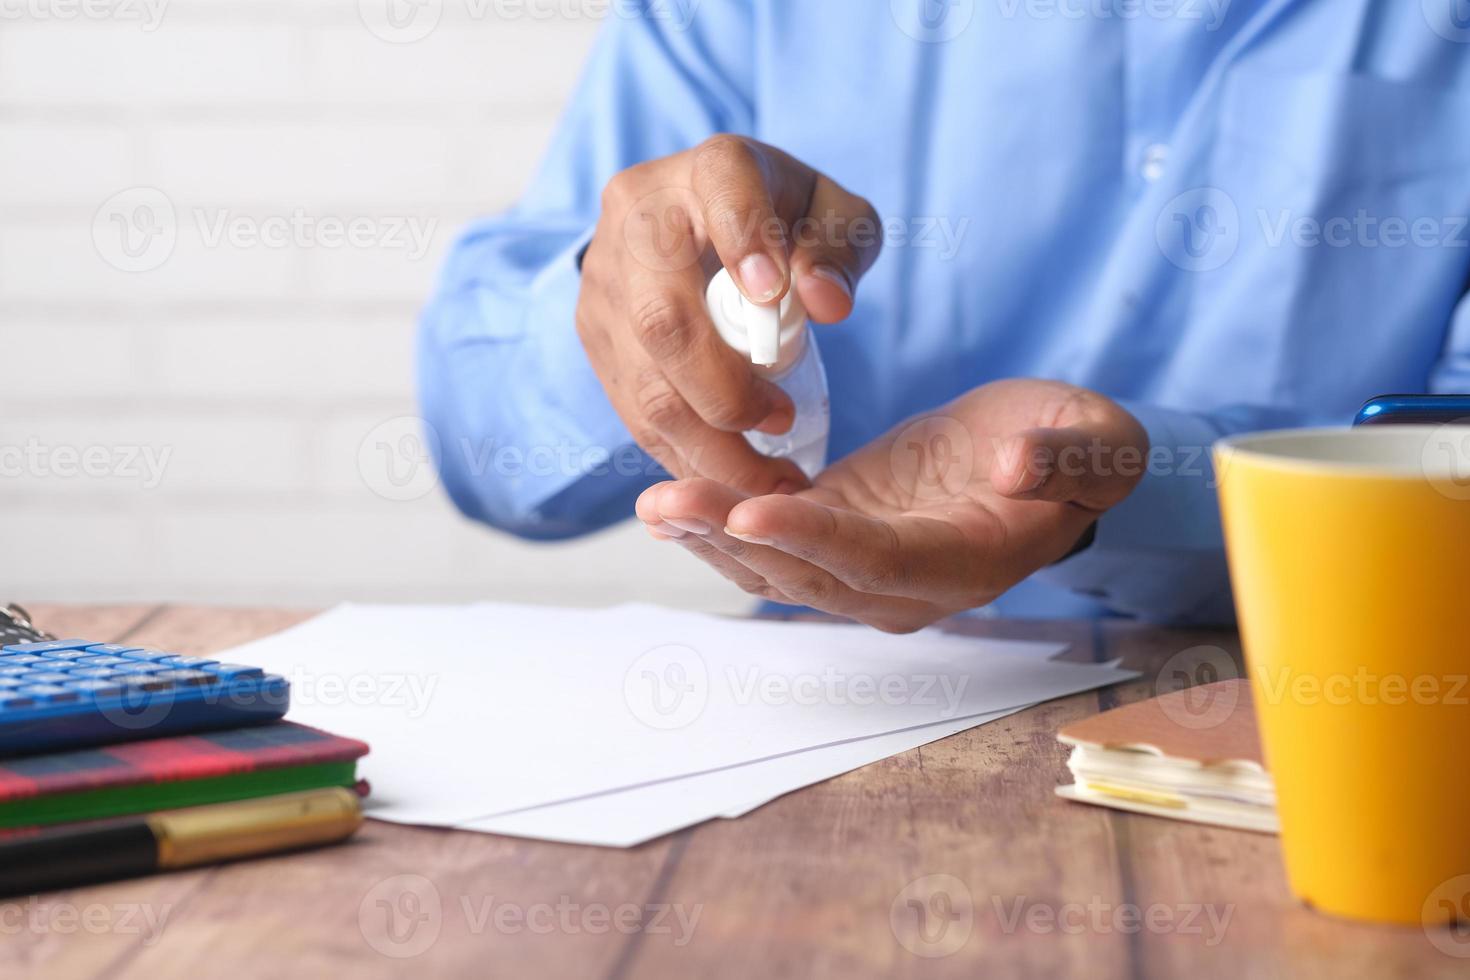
417,0,753,539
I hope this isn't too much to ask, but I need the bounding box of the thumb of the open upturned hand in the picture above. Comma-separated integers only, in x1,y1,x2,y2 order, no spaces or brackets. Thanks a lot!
991,423,1148,511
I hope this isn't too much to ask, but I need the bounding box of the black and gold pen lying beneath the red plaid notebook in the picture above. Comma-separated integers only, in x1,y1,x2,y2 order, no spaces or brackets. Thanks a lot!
0,786,363,895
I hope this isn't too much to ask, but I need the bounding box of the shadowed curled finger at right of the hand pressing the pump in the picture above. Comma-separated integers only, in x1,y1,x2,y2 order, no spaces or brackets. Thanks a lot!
791,175,882,323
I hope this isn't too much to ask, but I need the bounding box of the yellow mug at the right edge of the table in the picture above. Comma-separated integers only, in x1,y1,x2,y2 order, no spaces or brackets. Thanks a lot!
1214,426,1470,926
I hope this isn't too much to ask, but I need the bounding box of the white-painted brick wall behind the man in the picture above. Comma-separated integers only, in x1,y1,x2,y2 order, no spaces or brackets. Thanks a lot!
0,0,747,610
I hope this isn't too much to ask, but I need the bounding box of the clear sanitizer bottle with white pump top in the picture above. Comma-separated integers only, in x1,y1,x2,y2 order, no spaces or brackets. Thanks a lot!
704,269,832,478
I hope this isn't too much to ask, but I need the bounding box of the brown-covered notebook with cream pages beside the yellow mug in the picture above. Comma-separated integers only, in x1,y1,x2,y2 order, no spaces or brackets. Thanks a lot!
1057,680,1279,833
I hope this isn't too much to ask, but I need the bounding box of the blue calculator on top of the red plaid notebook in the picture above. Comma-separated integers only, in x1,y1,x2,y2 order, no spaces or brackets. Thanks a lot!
0,639,291,757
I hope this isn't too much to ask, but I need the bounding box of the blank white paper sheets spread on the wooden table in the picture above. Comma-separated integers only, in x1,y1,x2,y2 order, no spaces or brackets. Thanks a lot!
220,604,1136,846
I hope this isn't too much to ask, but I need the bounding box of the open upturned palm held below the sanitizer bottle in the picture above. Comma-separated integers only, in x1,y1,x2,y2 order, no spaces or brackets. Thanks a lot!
638,381,1148,632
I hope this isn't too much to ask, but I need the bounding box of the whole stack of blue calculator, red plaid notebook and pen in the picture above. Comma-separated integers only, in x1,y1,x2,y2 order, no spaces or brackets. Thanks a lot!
0,607,368,895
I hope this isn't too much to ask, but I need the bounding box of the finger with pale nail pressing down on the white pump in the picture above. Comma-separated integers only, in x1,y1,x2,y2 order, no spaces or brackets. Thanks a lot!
691,134,813,303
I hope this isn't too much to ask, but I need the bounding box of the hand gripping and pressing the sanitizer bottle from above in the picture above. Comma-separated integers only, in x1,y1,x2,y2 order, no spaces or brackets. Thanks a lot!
576,135,881,494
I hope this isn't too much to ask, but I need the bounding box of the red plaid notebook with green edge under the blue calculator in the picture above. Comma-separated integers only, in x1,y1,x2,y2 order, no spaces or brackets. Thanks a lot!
0,721,368,827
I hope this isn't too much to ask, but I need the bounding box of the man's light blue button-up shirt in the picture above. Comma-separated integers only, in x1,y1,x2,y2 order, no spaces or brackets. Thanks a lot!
419,0,1470,621
